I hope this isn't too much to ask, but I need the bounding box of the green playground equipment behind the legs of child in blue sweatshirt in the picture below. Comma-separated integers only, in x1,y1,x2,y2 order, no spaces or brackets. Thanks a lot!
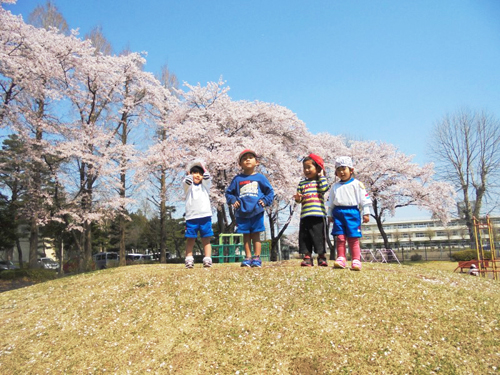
212,233,270,263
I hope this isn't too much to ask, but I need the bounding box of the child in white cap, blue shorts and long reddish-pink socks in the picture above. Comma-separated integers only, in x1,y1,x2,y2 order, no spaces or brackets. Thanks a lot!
328,156,372,271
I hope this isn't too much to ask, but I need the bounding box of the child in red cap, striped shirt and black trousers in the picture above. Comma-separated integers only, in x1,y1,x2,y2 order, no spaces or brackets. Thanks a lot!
293,154,330,267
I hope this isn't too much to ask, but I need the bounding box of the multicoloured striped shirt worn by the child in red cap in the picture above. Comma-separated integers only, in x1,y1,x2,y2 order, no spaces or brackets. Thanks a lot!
297,176,330,219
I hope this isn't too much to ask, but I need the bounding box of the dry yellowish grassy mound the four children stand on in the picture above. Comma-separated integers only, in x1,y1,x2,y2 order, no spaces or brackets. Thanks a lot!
0,261,500,374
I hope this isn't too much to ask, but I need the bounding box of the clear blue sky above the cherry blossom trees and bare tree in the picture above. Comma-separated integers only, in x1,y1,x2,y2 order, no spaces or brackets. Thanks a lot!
5,0,500,219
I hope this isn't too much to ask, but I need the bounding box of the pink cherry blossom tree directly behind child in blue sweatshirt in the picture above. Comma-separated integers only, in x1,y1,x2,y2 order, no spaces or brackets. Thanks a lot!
162,81,324,258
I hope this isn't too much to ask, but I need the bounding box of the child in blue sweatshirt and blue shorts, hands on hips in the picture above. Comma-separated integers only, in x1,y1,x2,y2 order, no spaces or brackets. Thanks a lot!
226,149,274,267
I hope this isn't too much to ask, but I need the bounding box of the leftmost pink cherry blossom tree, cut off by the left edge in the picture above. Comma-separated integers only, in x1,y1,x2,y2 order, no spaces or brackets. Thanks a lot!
0,8,82,267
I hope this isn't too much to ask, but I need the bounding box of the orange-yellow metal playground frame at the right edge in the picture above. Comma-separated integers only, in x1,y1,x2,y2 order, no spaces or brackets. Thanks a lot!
472,216,499,280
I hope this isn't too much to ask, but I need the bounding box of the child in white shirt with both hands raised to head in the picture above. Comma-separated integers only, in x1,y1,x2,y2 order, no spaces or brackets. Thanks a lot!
183,161,214,268
